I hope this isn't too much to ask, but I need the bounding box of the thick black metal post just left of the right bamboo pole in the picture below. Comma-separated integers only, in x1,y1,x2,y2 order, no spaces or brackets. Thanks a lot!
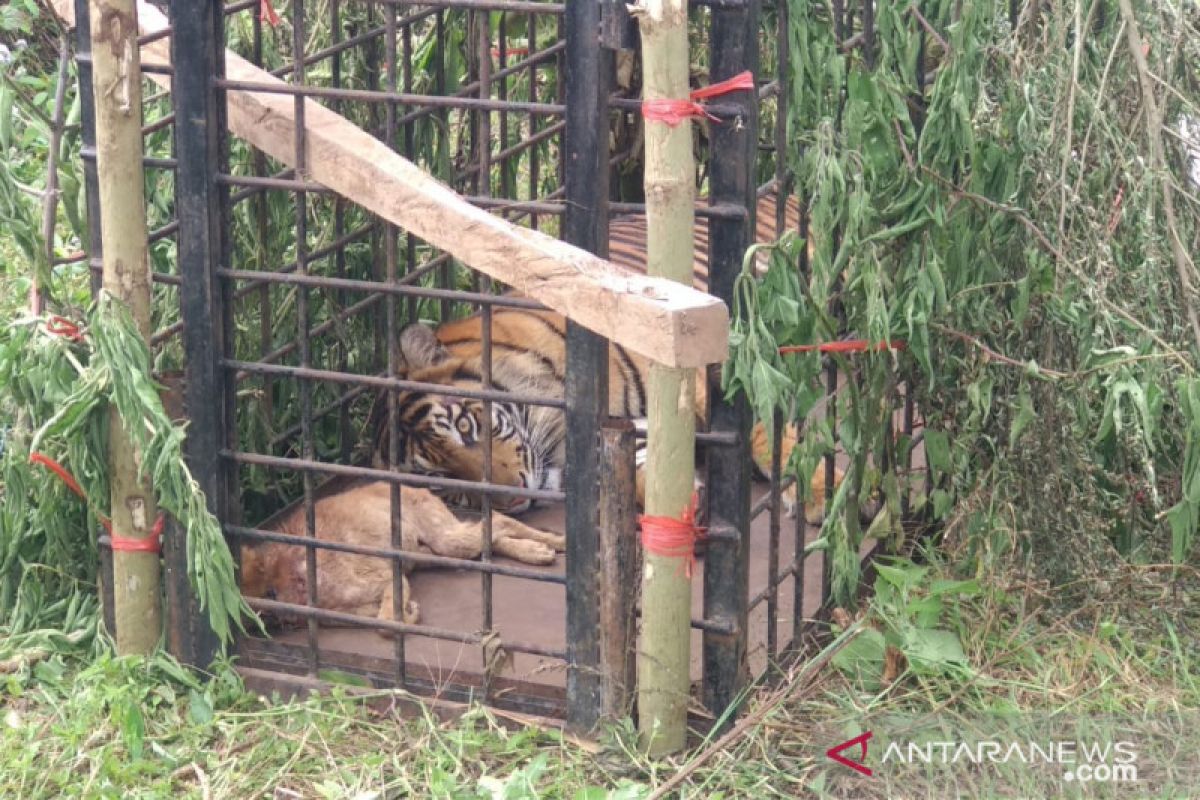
559,2,609,732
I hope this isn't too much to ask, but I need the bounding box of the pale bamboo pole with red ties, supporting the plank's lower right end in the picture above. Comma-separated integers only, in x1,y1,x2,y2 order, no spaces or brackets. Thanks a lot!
632,0,696,756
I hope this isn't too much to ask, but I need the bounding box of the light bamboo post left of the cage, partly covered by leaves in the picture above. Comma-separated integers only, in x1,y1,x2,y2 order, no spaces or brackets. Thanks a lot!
89,0,162,655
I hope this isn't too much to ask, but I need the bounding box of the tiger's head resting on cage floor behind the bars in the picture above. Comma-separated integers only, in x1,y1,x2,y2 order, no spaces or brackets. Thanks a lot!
376,324,559,513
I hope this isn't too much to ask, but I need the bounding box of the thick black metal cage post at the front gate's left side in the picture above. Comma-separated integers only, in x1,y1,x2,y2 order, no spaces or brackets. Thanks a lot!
168,2,229,667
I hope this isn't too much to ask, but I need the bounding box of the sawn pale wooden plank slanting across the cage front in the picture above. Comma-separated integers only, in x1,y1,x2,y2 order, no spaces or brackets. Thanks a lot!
52,0,728,367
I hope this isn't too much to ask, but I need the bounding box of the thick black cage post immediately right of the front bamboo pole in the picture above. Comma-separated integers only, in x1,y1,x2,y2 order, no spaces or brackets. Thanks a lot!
704,0,761,714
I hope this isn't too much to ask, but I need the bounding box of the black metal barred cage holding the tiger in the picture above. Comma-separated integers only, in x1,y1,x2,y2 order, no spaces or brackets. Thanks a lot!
76,0,914,729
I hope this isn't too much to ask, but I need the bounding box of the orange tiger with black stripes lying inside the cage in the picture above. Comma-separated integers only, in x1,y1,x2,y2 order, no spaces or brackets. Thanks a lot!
371,196,842,523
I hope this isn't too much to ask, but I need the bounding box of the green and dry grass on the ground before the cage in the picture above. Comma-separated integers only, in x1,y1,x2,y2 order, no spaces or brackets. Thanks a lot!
0,546,1200,800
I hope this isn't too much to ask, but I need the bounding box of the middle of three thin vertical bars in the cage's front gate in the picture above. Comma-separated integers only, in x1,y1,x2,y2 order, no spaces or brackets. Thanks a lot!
384,5,408,687
